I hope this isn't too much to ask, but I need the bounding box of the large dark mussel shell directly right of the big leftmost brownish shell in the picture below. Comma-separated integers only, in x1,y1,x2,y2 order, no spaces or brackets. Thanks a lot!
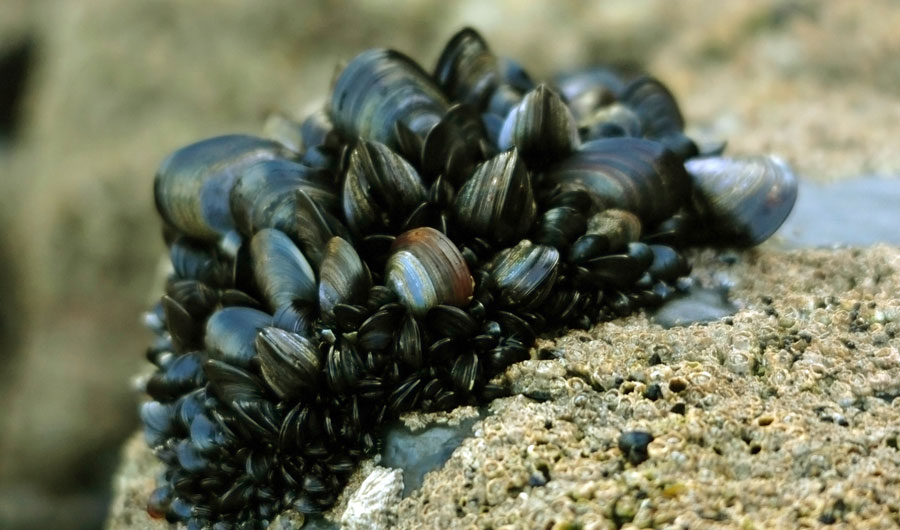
230,159,338,238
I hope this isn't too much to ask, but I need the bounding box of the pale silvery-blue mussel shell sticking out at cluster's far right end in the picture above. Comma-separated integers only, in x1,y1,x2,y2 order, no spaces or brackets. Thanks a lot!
685,156,797,246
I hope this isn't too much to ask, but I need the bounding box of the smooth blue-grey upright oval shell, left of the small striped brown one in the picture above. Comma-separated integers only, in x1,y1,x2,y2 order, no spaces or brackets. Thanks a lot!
250,228,317,312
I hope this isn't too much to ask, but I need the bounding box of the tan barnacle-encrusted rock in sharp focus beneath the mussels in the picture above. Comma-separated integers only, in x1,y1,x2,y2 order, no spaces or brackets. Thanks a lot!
109,246,900,529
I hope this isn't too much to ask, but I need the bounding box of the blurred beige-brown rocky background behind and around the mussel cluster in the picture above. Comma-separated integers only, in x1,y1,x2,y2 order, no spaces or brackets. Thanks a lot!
0,0,900,530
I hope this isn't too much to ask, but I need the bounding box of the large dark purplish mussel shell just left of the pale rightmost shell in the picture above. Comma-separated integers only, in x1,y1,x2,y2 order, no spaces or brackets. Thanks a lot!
548,137,691,225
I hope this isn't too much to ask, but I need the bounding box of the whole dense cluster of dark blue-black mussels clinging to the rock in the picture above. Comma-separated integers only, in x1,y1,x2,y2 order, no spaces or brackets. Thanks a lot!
140,28,796,530
